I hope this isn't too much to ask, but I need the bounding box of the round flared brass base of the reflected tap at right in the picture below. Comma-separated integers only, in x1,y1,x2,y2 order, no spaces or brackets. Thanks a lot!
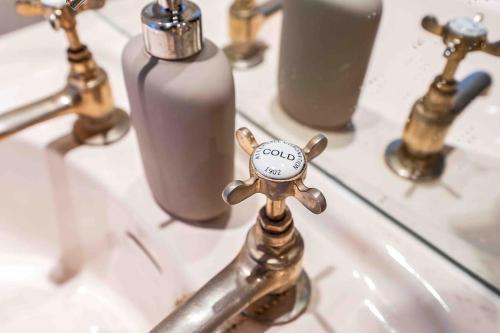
385,139,445,182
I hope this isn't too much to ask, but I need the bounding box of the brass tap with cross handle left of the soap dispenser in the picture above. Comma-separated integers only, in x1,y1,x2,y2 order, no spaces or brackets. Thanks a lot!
0,0,130,145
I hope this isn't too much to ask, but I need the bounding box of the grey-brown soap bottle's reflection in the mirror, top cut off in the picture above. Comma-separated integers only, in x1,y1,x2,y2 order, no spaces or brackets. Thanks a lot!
278,0,382,129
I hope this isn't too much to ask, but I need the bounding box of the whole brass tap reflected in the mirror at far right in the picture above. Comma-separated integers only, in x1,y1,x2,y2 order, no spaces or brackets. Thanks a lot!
385,15,500,181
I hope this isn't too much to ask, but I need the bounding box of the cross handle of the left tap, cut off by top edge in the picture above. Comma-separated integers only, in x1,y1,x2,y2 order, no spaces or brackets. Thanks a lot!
16,0,106,16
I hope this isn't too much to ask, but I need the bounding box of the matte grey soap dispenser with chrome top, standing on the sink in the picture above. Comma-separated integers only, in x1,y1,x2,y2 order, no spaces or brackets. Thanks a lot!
122,0,235,221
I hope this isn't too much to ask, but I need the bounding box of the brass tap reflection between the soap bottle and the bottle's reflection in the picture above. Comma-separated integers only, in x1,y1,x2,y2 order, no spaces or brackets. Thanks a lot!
224,0,284,69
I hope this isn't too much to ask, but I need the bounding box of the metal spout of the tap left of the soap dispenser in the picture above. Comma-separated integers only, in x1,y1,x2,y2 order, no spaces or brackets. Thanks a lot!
0,86,79,140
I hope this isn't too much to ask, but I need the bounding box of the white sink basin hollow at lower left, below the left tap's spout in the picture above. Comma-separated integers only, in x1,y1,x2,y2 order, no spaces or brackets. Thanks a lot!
0,140,181,333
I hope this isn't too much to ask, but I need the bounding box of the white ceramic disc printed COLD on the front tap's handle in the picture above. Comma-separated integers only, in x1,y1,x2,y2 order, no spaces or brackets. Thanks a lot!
252,140,305,180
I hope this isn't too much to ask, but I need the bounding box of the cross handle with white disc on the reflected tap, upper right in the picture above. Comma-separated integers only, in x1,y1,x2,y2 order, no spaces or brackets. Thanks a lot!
422,14,500,59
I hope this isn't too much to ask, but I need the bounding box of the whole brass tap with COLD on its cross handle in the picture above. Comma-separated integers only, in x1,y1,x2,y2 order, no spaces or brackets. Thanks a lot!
151,128,327,333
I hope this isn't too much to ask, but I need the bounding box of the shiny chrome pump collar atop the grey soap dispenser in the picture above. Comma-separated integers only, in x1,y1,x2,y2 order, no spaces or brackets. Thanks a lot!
142,0,203,60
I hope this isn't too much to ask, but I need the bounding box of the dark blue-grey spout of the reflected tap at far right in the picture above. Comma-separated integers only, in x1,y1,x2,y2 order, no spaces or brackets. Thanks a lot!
453,71,492,114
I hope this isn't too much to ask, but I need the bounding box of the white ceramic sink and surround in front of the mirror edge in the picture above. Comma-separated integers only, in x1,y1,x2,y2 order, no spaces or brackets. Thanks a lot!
0,0,500,333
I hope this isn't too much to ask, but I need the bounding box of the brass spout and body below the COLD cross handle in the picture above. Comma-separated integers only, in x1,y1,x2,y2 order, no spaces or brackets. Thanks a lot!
150,208,304,333
